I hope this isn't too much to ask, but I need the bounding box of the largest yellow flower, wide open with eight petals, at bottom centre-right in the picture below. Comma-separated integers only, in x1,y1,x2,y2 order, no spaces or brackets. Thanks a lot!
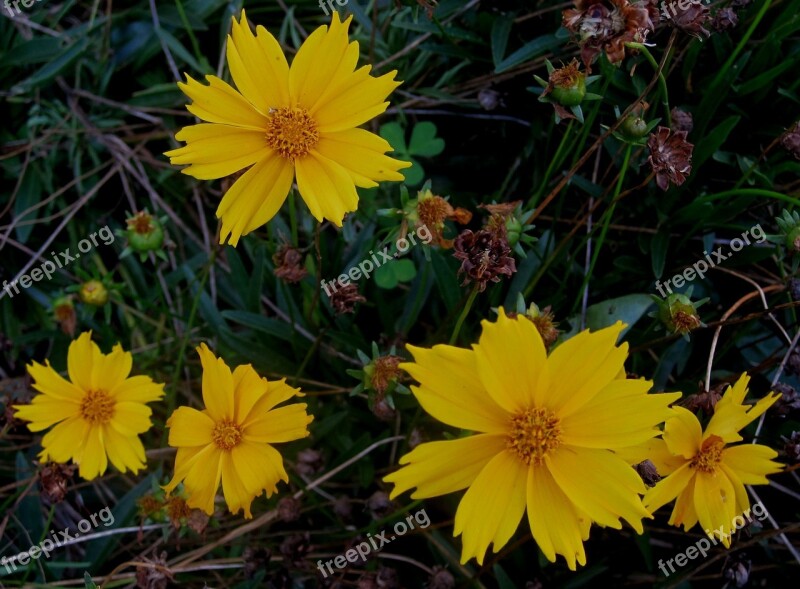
384,309,680,570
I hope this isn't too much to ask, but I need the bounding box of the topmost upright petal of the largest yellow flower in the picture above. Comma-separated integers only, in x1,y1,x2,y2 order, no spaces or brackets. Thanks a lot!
473,307,550,413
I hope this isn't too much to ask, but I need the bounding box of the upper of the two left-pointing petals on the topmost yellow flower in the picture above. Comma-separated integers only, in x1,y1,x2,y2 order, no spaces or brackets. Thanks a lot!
178,74,267,131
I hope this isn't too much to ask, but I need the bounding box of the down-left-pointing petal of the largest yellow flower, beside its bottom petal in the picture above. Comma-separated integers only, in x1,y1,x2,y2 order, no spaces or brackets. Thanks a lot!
453,451,528,564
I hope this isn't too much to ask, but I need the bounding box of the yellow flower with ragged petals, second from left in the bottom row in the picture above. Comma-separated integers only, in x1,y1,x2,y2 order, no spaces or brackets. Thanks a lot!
164,344,314,518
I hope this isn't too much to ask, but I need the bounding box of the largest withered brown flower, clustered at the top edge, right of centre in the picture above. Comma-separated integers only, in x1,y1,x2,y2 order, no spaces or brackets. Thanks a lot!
562,0,657,71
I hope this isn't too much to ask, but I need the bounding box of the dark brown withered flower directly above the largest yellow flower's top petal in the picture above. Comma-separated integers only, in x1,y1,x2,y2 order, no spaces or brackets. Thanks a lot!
453,229,517,292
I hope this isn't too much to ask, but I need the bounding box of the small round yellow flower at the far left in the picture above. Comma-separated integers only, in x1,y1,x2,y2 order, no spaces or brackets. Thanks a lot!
14,331,164,480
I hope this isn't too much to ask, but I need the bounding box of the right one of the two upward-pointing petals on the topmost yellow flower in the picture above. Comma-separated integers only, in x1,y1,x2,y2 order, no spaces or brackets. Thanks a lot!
289,13,358,114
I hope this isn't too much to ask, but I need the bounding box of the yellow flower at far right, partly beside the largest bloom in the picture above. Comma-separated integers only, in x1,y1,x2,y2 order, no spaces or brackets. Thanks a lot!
643,374,781,547
